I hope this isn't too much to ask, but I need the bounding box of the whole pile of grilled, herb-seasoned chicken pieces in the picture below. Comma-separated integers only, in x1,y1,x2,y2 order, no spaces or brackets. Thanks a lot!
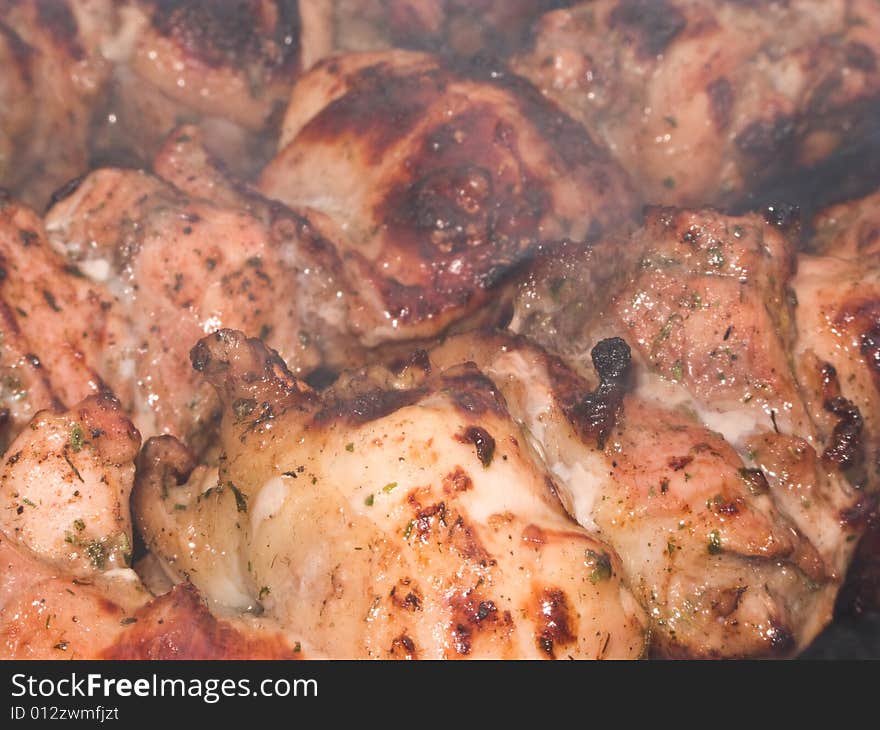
0,0,880,658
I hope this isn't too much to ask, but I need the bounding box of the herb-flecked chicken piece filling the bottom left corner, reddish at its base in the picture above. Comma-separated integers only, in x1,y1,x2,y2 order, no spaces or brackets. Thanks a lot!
0,396,295,659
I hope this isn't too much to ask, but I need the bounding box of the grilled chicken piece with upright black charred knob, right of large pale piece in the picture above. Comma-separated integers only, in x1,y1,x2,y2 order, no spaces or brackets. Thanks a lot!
431,334,839,657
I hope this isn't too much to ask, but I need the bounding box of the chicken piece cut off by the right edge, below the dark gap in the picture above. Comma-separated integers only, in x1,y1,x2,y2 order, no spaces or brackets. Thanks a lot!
792,193,880,610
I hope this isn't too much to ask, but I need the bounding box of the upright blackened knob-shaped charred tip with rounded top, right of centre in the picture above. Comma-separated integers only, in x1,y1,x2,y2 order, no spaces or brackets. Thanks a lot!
563,337,632,449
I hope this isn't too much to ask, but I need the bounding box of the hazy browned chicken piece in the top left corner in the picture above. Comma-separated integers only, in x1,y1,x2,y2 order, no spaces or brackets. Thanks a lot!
0,0,112,208
